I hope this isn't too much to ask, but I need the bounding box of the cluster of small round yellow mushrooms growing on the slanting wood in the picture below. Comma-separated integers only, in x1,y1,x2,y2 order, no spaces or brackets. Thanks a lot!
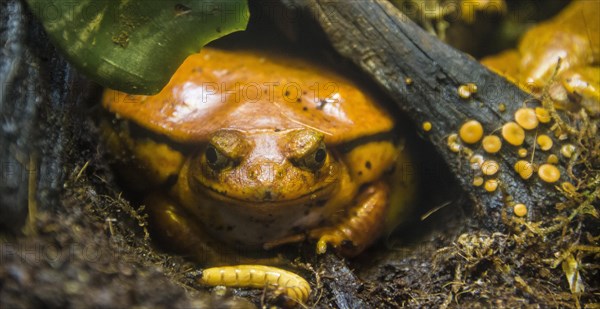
446,100,576,217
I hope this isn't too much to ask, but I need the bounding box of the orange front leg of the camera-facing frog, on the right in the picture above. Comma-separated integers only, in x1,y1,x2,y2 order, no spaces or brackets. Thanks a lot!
309,181,389,256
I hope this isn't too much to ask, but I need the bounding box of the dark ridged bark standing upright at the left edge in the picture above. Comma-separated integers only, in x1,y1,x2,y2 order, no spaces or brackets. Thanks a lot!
0,1,89,232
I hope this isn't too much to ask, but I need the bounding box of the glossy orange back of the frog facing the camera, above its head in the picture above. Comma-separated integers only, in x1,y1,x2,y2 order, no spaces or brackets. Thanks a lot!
104,48,394,145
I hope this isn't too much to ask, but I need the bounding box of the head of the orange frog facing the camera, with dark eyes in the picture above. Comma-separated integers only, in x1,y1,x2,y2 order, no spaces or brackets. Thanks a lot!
188,129,339,204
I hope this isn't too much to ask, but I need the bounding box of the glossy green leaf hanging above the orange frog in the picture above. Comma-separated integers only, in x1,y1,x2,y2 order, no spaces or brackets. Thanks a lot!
27,0,249,94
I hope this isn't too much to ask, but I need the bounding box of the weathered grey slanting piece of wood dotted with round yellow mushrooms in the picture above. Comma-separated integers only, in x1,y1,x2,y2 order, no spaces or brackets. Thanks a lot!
295,0,569,230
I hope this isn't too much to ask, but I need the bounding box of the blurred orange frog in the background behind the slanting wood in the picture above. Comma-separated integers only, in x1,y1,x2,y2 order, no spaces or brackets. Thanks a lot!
482,1,600,115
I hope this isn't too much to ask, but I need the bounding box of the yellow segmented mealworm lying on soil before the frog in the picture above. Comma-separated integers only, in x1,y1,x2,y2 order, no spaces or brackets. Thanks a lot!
200,265,310,303
